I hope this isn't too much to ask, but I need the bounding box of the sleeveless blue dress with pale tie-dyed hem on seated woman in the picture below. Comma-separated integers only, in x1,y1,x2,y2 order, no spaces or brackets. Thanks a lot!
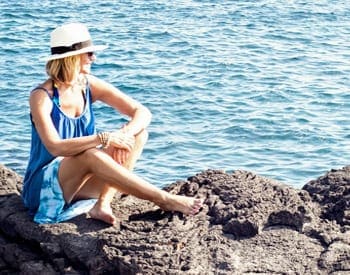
22,85,96,223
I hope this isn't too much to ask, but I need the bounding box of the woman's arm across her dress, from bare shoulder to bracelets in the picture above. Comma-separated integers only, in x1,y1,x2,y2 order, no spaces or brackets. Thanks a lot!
29,90,101,156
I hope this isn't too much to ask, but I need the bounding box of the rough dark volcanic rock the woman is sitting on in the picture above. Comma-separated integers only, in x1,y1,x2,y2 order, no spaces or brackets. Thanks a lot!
0,166,350,274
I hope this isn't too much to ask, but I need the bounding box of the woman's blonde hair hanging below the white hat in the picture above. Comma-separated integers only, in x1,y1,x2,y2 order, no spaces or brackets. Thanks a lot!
46,55,80,84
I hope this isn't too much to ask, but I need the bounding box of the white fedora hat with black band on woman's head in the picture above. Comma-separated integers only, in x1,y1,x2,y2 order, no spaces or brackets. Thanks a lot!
45,23,107,61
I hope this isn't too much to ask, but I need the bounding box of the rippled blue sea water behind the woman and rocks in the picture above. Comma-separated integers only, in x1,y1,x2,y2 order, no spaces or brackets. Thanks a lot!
0,0,350,190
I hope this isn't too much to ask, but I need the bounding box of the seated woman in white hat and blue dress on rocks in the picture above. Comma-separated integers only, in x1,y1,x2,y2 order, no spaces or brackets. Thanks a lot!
22,23,202,224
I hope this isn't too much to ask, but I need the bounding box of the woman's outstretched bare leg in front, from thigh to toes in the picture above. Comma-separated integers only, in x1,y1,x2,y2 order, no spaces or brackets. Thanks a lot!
59,148,202,222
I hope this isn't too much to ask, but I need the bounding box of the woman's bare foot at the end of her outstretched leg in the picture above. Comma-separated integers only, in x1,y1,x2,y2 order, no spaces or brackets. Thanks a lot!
159,194,203,215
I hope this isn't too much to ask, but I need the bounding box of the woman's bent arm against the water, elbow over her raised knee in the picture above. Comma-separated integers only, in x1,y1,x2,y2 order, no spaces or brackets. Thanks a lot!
88,75,152,136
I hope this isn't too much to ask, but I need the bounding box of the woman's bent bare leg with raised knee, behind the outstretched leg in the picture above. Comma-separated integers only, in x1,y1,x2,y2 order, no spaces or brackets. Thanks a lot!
74,131,148,224
